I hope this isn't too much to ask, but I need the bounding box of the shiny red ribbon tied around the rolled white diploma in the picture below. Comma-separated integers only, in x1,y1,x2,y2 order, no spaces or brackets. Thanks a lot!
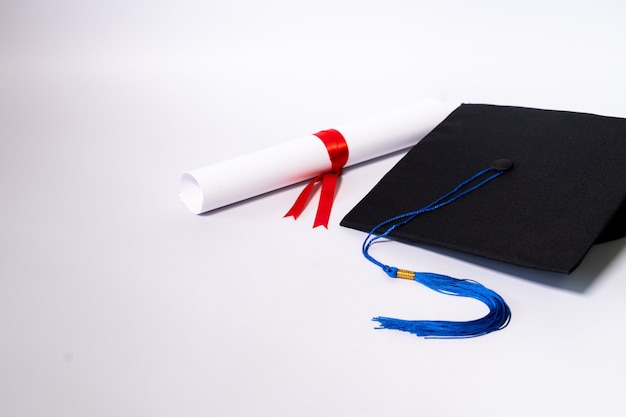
285,129,348,229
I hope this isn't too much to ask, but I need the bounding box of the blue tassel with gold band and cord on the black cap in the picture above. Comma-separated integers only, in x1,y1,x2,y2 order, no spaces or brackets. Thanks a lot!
362,160,511,339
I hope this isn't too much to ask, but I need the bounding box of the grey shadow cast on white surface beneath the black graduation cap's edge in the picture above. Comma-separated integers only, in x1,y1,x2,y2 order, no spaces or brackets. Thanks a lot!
410,238,626,293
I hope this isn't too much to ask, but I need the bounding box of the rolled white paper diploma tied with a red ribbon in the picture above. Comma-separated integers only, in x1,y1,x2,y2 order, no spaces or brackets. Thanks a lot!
180,99,453,214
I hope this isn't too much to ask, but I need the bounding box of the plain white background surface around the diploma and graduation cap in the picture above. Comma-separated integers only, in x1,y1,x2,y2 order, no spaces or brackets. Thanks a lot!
0,0,626,417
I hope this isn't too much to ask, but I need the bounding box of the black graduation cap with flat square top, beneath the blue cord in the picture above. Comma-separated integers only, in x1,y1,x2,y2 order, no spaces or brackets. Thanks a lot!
341,104,626,273
